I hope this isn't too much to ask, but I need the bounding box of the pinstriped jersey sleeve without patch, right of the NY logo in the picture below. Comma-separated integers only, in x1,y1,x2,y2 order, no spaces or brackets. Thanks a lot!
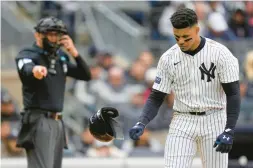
218,49,240,83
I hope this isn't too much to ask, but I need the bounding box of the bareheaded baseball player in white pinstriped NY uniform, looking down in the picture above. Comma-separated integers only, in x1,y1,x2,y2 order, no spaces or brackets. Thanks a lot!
129,8,240,168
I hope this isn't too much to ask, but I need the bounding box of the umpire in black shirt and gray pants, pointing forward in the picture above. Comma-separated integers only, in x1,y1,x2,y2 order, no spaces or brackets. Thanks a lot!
15,17,91,168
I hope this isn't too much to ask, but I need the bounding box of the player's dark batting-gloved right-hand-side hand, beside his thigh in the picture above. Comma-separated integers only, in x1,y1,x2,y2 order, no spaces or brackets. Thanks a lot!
213,129,234,153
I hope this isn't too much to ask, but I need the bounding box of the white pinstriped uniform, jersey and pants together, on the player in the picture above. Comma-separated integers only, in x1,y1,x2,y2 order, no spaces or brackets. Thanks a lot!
153,38,239,168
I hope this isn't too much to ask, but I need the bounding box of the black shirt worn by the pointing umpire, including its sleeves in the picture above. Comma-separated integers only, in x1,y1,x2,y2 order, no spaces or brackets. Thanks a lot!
15,44,91,112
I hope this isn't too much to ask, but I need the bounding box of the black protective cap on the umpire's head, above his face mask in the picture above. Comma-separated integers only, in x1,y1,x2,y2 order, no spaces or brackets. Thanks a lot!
34,16,68,34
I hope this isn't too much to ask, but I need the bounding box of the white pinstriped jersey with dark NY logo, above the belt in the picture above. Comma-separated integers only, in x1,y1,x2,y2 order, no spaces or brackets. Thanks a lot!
153,38,239,112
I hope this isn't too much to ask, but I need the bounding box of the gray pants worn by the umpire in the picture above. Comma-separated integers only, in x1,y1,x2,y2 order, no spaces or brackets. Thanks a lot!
26,114,64,168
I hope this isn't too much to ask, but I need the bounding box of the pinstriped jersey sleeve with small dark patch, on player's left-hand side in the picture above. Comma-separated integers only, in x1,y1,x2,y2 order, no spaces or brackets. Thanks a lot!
153,55,173,94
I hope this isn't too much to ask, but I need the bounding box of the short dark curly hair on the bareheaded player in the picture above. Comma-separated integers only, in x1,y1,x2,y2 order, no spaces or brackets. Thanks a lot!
170,8,198,29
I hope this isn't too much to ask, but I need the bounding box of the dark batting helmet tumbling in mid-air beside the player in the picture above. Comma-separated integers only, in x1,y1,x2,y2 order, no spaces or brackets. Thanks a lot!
89,107,124,142
